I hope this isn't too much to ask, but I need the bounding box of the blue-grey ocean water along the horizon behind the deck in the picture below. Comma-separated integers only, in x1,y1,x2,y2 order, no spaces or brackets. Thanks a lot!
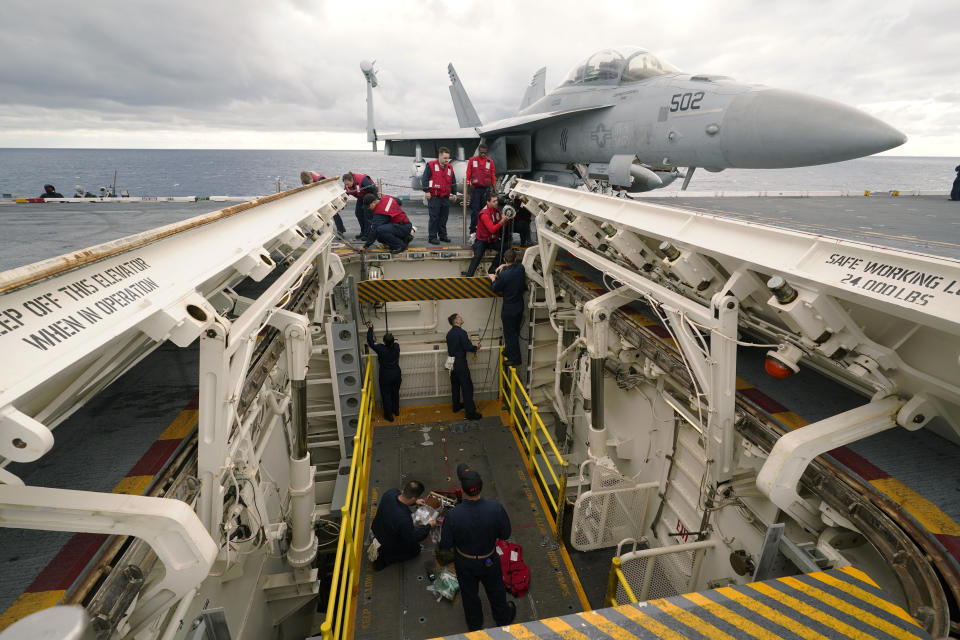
0,149,960,197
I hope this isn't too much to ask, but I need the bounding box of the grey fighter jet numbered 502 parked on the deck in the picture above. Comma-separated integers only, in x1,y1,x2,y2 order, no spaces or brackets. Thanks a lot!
364,47,906,192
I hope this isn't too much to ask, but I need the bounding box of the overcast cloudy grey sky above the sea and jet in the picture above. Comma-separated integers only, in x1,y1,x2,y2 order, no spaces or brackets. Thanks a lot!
0,0,960,156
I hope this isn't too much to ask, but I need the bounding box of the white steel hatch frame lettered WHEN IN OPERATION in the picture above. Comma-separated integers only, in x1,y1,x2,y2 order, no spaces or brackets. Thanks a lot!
0,180,346,637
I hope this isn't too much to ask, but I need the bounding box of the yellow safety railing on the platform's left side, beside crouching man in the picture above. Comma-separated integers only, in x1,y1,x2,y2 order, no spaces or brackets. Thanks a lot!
320,356,373,640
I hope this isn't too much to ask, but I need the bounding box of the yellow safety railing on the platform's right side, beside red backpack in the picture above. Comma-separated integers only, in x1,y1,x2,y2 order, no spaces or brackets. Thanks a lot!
499,347,570,540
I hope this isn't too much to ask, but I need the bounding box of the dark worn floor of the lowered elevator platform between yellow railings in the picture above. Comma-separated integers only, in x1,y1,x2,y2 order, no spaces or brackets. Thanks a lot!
355,410,584,640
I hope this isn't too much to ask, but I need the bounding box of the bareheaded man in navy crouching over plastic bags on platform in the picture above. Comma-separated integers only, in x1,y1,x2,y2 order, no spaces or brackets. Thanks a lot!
370,480,436,571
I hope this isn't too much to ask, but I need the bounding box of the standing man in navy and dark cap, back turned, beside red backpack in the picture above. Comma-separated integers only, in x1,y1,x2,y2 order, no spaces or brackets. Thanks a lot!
440,463,517,631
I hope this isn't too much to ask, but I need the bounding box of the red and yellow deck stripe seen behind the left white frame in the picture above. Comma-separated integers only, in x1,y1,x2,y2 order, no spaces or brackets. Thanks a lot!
0,397,199,631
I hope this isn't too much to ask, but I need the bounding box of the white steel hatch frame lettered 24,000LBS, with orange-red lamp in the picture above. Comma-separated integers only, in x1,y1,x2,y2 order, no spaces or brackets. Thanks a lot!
512,180,960,632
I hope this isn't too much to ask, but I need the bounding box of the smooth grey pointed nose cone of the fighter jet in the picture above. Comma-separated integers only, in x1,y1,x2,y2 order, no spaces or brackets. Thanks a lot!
720,89,907,169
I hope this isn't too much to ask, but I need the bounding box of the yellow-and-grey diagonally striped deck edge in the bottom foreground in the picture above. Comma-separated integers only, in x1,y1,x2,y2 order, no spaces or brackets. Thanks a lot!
436,568,930,640
